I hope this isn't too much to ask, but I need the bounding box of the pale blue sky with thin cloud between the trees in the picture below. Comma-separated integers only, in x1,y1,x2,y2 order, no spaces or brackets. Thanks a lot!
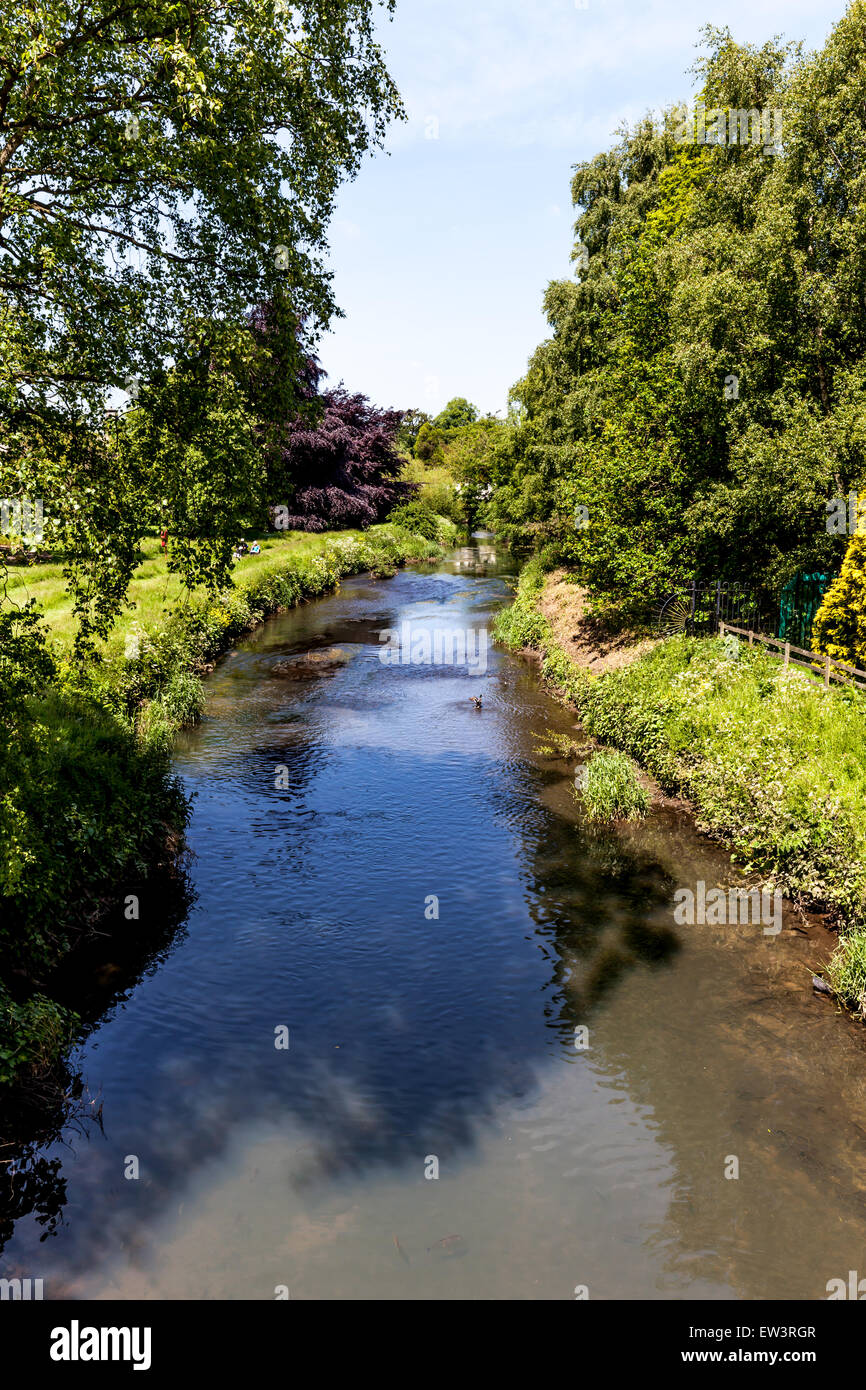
320,0,845,413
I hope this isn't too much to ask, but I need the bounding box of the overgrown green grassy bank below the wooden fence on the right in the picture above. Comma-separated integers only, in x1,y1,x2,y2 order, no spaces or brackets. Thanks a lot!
495,560,866,1015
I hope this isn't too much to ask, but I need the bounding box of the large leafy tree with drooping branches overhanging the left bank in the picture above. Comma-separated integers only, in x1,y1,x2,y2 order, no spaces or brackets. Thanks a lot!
0,0,400,644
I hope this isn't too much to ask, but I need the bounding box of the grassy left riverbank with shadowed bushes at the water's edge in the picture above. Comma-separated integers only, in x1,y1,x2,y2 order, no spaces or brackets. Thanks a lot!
0,525,447,1084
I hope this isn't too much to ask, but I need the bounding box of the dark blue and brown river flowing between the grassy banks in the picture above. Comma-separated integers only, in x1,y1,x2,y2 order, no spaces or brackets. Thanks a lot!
0,545,866,1300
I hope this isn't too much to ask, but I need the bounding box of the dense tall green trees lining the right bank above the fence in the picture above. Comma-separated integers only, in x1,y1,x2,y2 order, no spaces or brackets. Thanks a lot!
489,9,866,609
